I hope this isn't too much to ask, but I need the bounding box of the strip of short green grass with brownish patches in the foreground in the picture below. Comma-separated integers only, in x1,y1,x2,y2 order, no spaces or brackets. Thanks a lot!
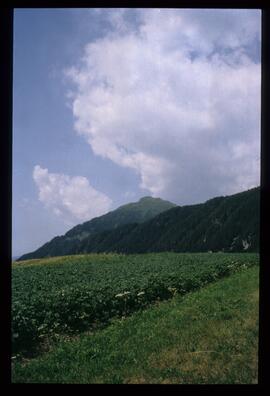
12,266,259,384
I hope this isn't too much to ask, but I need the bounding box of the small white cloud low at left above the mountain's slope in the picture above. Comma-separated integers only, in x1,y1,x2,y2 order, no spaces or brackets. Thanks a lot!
33,165,112,224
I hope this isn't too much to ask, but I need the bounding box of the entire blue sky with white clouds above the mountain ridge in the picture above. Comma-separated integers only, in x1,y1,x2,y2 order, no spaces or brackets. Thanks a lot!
12,8,261,256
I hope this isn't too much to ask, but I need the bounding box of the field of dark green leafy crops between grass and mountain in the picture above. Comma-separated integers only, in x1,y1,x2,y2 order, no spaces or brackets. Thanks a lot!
12,253,259,354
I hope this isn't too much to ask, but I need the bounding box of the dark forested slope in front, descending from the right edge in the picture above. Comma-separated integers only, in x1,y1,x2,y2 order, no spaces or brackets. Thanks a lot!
69,188,260,254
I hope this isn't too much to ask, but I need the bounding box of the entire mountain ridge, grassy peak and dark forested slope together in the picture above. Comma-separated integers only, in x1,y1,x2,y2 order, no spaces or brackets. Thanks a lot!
17,188,260,259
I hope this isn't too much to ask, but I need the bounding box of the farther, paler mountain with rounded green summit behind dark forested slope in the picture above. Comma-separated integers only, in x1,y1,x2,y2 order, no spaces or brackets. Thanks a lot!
18,197,177,261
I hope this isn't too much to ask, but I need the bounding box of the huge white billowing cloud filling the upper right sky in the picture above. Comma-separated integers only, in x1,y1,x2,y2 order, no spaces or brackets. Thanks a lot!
66,9,260,204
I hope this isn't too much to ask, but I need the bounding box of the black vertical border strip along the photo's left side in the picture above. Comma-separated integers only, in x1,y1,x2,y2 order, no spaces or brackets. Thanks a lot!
0,8,13,386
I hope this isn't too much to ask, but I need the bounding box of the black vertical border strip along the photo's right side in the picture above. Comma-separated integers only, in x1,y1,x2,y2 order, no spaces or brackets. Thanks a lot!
259,8,270,390
